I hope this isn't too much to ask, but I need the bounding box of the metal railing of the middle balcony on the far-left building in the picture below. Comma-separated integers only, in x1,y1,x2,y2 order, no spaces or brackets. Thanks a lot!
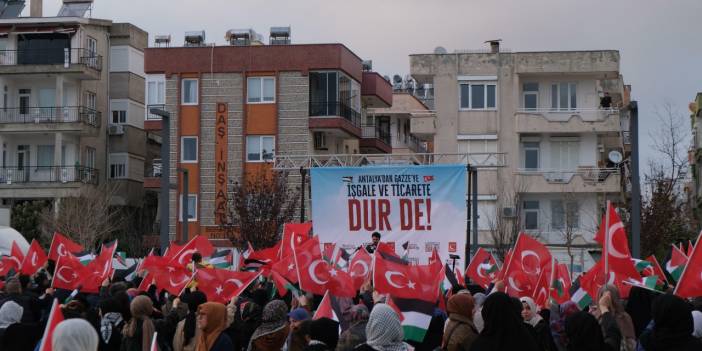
0,106,101,128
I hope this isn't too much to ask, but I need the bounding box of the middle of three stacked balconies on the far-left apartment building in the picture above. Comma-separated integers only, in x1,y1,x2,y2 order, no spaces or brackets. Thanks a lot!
0,106,102,133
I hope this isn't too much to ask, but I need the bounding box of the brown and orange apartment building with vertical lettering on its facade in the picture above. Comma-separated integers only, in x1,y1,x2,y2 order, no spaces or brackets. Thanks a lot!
145,27,393,239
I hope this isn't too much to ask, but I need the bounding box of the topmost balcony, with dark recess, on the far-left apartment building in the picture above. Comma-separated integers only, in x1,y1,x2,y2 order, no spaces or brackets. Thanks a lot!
0,48,102,79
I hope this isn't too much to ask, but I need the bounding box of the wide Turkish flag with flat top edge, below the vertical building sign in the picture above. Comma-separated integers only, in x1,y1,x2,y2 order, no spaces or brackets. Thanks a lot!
195,268,261,304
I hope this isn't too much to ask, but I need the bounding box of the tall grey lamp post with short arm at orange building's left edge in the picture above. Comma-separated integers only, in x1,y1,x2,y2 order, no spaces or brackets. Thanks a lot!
149,108,171,255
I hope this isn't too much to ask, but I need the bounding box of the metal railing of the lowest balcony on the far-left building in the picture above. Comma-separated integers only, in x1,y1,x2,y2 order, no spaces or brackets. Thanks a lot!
0,166,99,186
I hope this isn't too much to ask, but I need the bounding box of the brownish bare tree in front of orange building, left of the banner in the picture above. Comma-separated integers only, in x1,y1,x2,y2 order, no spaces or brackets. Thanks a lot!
222,170,299,249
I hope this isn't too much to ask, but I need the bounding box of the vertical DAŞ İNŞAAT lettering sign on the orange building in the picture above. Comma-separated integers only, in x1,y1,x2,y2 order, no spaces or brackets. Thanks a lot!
215,103,229,225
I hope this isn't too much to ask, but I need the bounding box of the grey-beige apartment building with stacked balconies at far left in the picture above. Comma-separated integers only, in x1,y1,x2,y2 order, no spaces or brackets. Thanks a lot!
0,0,147,212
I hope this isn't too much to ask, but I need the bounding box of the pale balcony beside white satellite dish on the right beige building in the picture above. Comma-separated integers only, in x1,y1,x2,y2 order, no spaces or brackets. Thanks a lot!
516,166,622,193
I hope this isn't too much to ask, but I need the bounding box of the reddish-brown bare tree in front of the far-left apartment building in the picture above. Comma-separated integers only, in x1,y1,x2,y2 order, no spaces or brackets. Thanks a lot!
41,183,128,249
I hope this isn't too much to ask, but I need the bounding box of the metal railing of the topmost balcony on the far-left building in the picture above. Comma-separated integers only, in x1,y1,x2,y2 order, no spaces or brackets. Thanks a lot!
0,48,102,71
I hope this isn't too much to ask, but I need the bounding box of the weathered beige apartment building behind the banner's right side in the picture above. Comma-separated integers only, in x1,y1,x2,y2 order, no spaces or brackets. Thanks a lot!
410,41,630,272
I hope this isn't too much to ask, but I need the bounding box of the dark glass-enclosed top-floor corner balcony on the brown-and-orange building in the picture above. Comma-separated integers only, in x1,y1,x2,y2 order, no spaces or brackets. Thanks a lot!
309,101,362,138
